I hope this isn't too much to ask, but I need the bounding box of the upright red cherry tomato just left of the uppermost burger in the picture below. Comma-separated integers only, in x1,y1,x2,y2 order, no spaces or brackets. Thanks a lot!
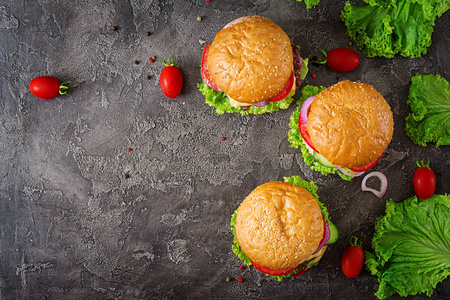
159,59,183,98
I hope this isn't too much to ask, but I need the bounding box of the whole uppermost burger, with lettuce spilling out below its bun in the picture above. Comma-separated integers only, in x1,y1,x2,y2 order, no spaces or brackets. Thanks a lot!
198,16,307,115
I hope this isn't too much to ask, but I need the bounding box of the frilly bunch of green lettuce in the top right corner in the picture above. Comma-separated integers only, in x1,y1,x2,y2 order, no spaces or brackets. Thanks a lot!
341,0,450,57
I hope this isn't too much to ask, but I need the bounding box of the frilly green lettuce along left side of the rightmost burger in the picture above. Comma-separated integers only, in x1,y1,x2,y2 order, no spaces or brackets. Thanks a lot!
288,85,353,180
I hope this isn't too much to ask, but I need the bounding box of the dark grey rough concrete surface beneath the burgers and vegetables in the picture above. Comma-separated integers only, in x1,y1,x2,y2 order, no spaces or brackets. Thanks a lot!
0,0,450,300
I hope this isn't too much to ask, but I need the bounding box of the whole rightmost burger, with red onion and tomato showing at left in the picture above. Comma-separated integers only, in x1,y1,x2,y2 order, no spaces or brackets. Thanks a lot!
289,80,394,180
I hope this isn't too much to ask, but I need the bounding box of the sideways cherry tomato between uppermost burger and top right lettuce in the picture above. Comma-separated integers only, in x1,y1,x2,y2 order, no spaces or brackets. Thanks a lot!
319,48,359,72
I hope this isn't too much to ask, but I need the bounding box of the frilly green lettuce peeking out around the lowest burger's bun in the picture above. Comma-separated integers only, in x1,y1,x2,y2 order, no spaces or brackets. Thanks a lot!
230,176,328,281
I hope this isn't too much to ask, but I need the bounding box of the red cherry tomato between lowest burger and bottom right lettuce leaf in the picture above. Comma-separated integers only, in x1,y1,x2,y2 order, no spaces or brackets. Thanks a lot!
341,237,364,278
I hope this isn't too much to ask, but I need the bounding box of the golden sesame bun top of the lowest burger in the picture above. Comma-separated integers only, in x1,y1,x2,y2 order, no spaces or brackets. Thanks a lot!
236,181,324,269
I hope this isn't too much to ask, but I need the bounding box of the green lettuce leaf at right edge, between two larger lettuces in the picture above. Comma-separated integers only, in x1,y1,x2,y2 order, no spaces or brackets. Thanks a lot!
405,74,450,147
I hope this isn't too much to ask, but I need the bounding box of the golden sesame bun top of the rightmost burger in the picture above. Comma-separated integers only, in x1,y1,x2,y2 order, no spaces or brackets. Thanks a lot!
307,81,394,168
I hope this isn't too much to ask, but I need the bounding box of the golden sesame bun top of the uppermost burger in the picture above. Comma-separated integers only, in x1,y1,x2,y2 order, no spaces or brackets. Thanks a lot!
207,16,293,103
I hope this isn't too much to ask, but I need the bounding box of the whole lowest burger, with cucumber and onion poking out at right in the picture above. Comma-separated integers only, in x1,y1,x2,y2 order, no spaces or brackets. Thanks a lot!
231,176,338,280
